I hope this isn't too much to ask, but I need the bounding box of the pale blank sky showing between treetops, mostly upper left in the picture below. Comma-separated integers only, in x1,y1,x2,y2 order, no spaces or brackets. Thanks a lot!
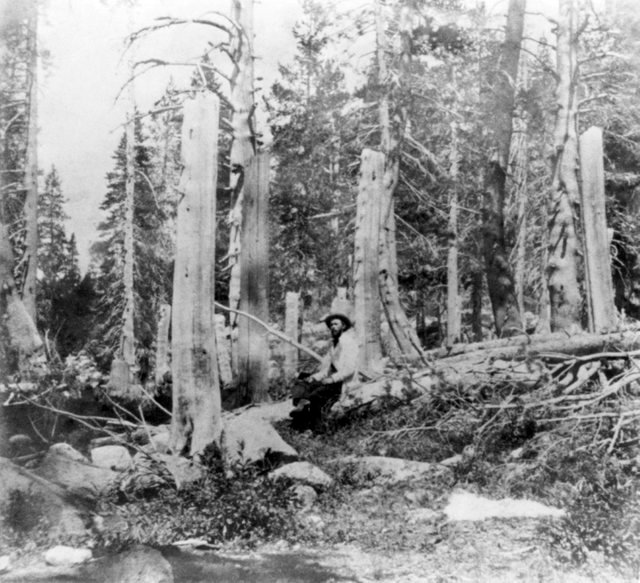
36,0,584,270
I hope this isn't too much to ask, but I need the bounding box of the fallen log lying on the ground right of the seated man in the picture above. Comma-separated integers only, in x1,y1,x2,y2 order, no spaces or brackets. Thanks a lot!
333,329,640,416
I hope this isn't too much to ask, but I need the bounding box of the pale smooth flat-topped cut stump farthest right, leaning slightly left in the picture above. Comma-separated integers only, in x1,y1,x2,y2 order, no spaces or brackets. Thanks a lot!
580,127,617,332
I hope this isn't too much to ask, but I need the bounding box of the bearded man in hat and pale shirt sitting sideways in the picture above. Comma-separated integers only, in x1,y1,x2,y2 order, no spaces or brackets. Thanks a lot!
290,314,358,431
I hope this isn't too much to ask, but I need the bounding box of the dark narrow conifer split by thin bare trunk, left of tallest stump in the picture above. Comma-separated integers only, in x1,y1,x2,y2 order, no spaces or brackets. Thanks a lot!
91,120,171,380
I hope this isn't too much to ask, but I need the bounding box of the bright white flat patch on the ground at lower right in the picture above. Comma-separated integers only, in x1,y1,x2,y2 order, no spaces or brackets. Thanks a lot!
444,492,565,522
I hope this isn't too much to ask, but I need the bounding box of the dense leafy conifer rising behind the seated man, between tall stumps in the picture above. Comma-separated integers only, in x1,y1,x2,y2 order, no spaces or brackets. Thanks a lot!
268,1,353,307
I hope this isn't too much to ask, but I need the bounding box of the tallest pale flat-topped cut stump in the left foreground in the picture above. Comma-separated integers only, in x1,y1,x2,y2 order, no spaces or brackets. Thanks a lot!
171,93,221,455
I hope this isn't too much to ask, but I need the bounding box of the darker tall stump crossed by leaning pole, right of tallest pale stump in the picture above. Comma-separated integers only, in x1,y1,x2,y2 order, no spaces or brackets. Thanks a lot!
238,152,270,403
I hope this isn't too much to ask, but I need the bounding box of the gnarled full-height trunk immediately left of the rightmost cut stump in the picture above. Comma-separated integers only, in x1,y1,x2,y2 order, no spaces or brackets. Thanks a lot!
547,0,582,332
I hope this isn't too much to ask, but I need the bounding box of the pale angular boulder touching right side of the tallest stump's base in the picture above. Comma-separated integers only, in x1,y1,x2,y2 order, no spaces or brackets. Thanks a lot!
221,408,298,465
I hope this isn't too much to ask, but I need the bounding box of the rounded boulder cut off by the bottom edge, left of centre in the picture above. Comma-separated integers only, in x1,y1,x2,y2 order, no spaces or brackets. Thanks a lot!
102,546,174,583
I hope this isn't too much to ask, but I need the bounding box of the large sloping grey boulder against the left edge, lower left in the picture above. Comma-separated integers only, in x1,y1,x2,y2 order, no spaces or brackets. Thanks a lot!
0,458,86,538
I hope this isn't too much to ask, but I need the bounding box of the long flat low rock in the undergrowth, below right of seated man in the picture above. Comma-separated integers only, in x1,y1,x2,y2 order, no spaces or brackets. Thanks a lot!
336,456,454,485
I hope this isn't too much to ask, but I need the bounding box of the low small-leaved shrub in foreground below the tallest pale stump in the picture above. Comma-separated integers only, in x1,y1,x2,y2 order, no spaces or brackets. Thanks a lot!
100,454,297,547
